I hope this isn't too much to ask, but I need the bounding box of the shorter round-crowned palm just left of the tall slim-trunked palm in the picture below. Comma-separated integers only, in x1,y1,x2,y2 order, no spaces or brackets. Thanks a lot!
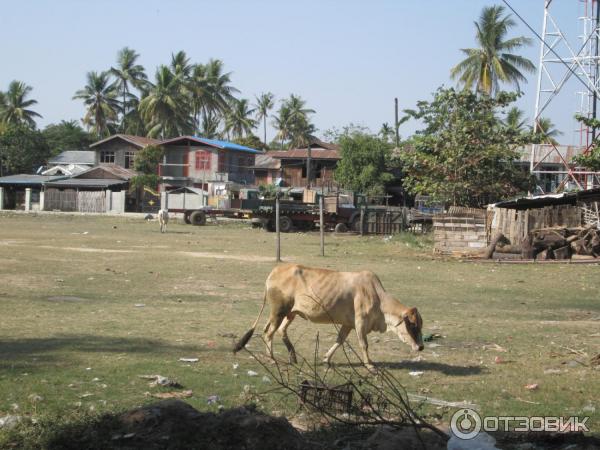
73,71,119,138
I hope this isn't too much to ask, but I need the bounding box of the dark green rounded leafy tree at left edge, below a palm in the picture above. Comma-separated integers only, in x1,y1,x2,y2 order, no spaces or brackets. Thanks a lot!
0,124,50,176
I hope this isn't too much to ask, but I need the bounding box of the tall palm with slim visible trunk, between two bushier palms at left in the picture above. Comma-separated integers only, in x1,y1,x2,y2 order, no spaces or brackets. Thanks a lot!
110,47,148,131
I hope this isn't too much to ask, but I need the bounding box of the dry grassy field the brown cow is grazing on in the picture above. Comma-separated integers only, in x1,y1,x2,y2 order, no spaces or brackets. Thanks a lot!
0,213,600,442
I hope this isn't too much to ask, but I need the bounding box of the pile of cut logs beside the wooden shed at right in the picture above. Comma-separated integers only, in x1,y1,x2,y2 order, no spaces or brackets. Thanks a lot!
484,225,600,261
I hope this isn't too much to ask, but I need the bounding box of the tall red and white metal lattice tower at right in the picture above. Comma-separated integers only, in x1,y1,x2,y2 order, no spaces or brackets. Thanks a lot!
530,0,600,190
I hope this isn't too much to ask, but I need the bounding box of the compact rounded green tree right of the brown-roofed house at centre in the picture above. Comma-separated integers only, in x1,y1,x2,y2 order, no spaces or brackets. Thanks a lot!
334,131,394,195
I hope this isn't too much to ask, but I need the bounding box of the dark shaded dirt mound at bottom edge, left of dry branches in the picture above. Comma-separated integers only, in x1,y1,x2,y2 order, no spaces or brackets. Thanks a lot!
50,400,311,450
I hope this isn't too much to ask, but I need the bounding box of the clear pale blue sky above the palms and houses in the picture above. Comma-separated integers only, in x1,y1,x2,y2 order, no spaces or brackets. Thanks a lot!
0,0,579,143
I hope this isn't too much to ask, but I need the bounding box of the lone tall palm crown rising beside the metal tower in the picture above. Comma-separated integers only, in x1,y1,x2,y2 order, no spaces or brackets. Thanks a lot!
450,5,535,95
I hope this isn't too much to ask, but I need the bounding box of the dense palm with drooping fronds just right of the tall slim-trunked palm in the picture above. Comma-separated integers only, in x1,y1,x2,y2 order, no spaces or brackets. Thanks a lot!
139,65,193,138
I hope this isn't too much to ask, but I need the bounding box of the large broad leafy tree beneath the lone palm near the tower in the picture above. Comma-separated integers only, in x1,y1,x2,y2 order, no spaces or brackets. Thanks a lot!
400,88,532,207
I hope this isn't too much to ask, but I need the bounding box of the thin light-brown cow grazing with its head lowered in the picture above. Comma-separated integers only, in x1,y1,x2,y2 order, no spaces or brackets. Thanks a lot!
233,264,423,369
